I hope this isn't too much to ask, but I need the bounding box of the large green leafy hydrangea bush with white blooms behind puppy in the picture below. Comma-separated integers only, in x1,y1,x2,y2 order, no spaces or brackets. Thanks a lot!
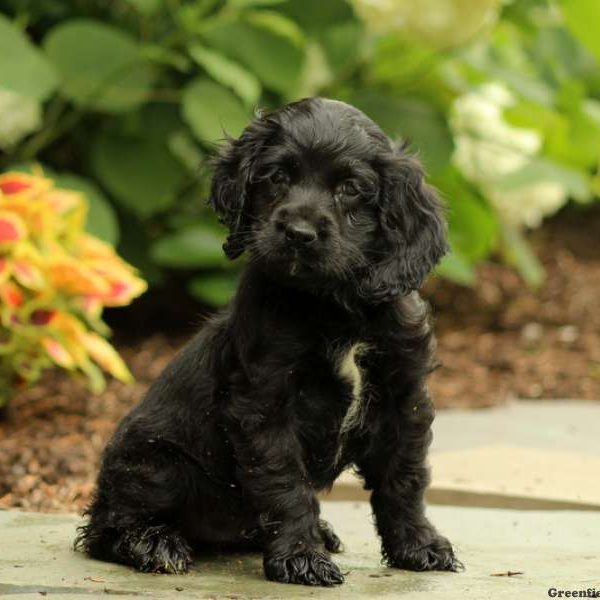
0,0,600,304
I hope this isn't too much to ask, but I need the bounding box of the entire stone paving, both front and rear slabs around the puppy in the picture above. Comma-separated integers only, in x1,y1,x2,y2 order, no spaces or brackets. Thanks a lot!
0,400,600,600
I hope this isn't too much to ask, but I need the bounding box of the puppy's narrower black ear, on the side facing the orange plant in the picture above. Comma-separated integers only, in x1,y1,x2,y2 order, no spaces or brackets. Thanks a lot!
210,115,272,259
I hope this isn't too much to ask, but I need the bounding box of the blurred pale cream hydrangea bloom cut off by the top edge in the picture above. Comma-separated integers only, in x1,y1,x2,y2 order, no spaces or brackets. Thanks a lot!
352,0,504,48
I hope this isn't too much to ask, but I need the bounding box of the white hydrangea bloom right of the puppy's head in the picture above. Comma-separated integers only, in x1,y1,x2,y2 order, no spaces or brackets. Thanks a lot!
451,83,568,227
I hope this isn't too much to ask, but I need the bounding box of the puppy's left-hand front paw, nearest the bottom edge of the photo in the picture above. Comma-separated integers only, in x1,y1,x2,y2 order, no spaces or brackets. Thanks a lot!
264,550,344,586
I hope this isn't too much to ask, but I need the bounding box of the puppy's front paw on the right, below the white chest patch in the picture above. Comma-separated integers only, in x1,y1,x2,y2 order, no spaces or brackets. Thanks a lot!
384,529,464,572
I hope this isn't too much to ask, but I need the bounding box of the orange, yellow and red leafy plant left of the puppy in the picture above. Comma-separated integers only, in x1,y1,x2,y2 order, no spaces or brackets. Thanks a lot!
0,173,146,406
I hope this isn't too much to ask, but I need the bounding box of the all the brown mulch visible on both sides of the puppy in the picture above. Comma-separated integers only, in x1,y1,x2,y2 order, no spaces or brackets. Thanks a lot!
0,210,600,512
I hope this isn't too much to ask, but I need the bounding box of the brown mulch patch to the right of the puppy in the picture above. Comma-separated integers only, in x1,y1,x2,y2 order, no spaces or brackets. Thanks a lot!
425,209,600,407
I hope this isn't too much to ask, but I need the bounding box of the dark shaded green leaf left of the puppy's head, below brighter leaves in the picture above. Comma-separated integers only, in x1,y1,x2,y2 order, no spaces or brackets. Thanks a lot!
91,125,184,218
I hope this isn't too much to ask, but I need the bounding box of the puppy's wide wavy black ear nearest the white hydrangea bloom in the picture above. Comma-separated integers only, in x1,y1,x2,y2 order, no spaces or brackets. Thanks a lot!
369,147,448,302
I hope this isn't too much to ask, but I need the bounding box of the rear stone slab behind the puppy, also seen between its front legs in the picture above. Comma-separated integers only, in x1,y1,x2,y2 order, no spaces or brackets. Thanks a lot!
328,400,600,510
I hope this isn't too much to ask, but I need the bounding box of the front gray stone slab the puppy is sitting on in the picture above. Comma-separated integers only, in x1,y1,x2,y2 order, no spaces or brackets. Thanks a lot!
0,502,600,600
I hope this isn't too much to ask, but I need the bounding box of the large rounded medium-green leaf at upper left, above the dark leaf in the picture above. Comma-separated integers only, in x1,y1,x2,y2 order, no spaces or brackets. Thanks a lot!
44,19,154,113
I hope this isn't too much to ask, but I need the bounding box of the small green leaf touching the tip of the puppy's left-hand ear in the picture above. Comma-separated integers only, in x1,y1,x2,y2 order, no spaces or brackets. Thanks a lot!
151,223,226,269
